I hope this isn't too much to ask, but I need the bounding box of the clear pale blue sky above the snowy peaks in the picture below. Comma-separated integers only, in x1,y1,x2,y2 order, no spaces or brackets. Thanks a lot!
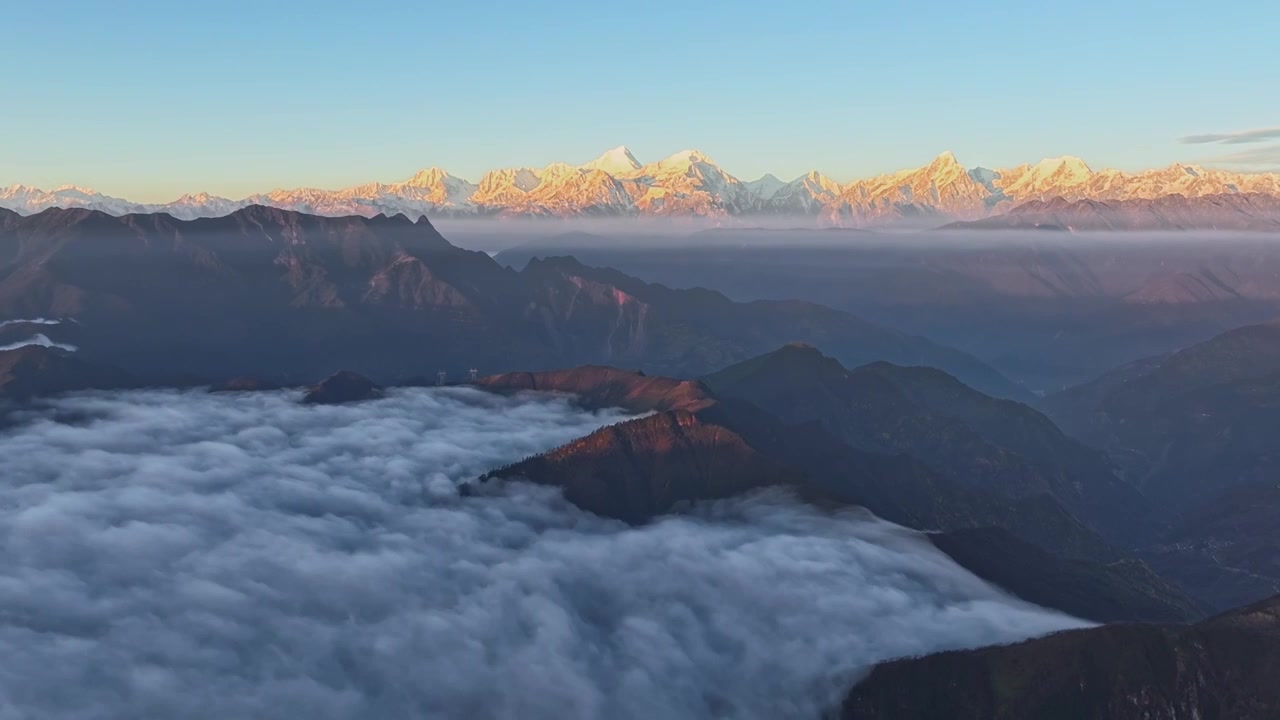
0,0,1280,201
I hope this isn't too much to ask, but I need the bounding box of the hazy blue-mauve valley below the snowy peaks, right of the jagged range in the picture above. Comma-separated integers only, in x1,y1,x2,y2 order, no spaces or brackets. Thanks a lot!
496,225,1280,392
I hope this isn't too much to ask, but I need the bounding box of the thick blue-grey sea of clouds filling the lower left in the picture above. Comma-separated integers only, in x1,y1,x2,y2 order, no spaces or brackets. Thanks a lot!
0,388,1082,719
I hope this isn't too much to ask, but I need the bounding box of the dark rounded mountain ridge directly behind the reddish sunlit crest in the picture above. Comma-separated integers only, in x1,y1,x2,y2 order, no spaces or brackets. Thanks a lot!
705,345,1146,542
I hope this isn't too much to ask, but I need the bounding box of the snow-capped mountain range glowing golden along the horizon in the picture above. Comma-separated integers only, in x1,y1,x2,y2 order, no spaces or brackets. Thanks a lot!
0,147,1280,227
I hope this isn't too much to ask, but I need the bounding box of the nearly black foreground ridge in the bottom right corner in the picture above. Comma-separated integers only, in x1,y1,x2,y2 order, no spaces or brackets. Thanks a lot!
842,597,1280,720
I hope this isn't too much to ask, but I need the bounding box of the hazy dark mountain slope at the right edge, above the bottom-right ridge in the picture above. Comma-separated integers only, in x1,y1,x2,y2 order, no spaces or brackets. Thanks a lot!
1041,323,1280,609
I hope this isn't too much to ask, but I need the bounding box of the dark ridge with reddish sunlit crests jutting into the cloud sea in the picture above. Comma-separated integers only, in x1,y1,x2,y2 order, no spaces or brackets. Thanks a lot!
479,350,1201,621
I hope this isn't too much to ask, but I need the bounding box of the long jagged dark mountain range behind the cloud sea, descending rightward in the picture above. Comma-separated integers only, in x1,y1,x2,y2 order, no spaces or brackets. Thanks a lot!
0,206,1023,396
